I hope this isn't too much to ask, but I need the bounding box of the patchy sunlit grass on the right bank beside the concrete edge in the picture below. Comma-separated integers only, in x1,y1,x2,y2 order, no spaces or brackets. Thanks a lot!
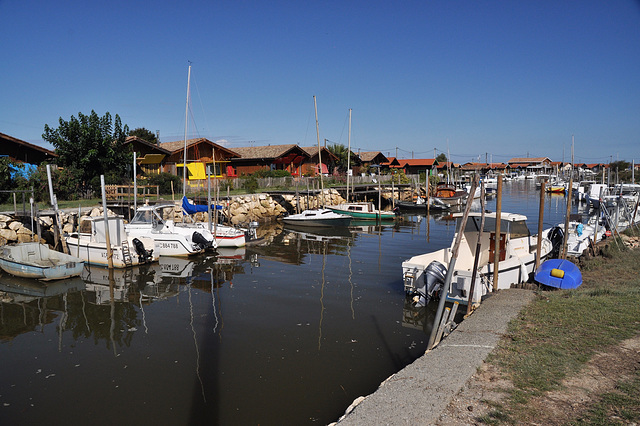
483,244,640,424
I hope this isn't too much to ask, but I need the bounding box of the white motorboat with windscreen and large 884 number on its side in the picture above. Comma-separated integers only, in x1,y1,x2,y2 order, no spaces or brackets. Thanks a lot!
124,206,211,256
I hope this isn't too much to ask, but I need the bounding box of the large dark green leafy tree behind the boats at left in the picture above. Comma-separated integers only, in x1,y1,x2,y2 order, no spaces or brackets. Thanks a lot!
42,110,129,195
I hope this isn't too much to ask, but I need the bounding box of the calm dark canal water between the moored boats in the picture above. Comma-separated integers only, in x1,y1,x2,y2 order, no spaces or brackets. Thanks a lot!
0,181,566,425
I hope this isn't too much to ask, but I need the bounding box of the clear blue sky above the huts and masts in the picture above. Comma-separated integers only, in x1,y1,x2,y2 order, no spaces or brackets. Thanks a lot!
0,0,640,163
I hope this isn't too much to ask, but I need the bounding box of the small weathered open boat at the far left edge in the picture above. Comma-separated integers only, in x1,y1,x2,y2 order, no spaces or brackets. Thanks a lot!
0,242,84,281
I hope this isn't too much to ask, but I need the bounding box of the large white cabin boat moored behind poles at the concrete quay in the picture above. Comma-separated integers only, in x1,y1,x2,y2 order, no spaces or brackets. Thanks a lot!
402,212,552,304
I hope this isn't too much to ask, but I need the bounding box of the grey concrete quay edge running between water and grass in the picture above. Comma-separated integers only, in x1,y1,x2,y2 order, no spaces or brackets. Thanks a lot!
338,289,535,426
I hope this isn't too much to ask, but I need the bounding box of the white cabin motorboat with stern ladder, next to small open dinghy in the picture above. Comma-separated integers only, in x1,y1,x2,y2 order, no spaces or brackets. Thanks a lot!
65,216,159,268
